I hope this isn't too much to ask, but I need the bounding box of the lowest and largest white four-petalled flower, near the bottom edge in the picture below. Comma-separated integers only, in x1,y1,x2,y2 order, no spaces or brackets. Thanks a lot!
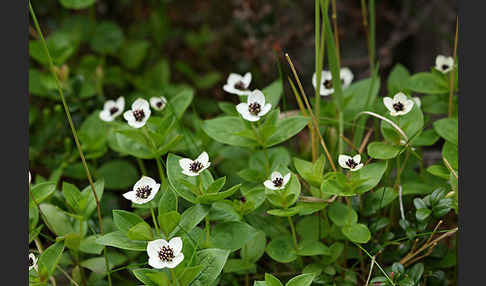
147,237,184,269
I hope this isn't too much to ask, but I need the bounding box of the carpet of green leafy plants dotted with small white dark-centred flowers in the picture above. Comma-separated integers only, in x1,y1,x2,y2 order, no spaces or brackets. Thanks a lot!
28,0,459,286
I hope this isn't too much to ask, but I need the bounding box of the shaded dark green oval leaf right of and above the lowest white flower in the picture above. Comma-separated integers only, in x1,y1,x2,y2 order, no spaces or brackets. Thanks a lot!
211,221,257,252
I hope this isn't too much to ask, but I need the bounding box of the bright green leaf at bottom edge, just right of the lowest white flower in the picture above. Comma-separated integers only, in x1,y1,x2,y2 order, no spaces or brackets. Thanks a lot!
191,248,230,286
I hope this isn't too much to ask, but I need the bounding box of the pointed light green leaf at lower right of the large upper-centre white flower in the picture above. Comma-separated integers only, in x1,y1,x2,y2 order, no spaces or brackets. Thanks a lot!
265,116,309,148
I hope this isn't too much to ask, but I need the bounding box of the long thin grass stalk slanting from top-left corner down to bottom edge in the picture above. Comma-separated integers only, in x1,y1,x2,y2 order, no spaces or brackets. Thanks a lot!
29,1,112,286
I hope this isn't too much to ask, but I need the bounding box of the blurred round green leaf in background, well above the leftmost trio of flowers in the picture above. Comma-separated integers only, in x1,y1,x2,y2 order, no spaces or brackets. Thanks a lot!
90,21,125,54
